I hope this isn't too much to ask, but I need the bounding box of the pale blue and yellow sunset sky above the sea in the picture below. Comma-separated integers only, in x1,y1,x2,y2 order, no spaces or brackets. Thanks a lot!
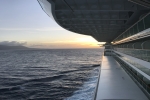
0,0,104,48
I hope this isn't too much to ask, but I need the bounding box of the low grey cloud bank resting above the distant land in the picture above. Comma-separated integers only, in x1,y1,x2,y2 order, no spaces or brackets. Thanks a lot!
0,41,27,46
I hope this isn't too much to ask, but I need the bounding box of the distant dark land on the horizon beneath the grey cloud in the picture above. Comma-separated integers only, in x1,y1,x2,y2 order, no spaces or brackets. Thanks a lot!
0,45,30,50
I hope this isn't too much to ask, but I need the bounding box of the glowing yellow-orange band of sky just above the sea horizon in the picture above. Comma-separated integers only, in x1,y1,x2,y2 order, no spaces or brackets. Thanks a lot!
26,36,105,48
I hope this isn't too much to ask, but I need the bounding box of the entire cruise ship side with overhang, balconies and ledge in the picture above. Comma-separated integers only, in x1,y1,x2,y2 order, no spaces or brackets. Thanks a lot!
38,0,150,100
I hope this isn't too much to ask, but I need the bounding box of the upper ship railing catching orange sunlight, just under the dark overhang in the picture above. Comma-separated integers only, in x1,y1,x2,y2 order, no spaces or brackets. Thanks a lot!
113,13,150,44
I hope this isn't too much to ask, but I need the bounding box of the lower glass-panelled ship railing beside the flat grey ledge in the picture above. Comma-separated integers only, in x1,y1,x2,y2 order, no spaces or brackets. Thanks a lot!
113,50,150,96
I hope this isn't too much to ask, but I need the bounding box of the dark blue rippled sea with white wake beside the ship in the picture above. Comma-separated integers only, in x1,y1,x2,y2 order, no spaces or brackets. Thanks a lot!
0,49,103,100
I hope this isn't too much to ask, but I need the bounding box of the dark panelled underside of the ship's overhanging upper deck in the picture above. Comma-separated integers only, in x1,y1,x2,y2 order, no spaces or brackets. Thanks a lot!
47,0,150,42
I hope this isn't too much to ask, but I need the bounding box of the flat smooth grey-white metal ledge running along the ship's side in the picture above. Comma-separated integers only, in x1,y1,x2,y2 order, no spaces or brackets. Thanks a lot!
96,56,148,100
